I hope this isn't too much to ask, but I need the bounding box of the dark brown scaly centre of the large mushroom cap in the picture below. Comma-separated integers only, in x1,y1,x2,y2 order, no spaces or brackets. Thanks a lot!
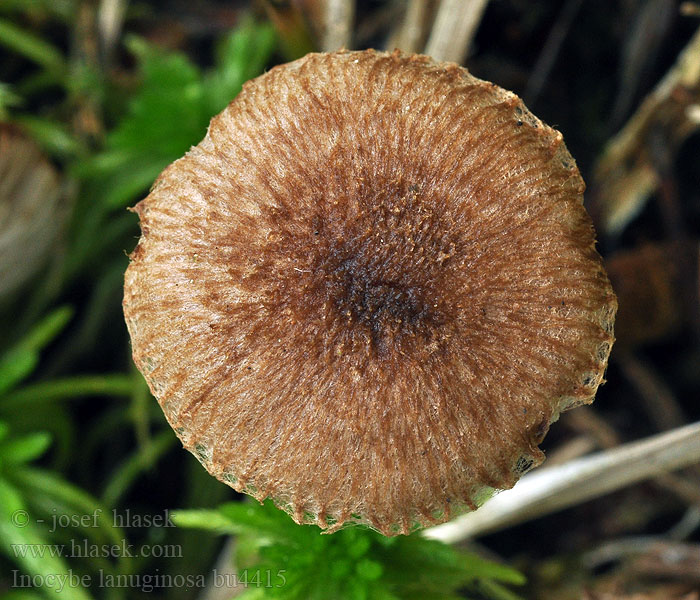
258,172,461,362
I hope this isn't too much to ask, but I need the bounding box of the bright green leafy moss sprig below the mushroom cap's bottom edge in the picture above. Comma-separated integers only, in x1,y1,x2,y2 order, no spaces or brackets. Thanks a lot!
175,501,524,600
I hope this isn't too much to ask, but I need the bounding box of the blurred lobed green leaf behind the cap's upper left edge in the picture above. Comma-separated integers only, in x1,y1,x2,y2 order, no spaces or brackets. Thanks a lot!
82,20,275,209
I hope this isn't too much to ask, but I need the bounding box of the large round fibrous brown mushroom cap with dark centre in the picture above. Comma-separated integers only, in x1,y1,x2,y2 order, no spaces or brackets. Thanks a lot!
124,50,616,535
